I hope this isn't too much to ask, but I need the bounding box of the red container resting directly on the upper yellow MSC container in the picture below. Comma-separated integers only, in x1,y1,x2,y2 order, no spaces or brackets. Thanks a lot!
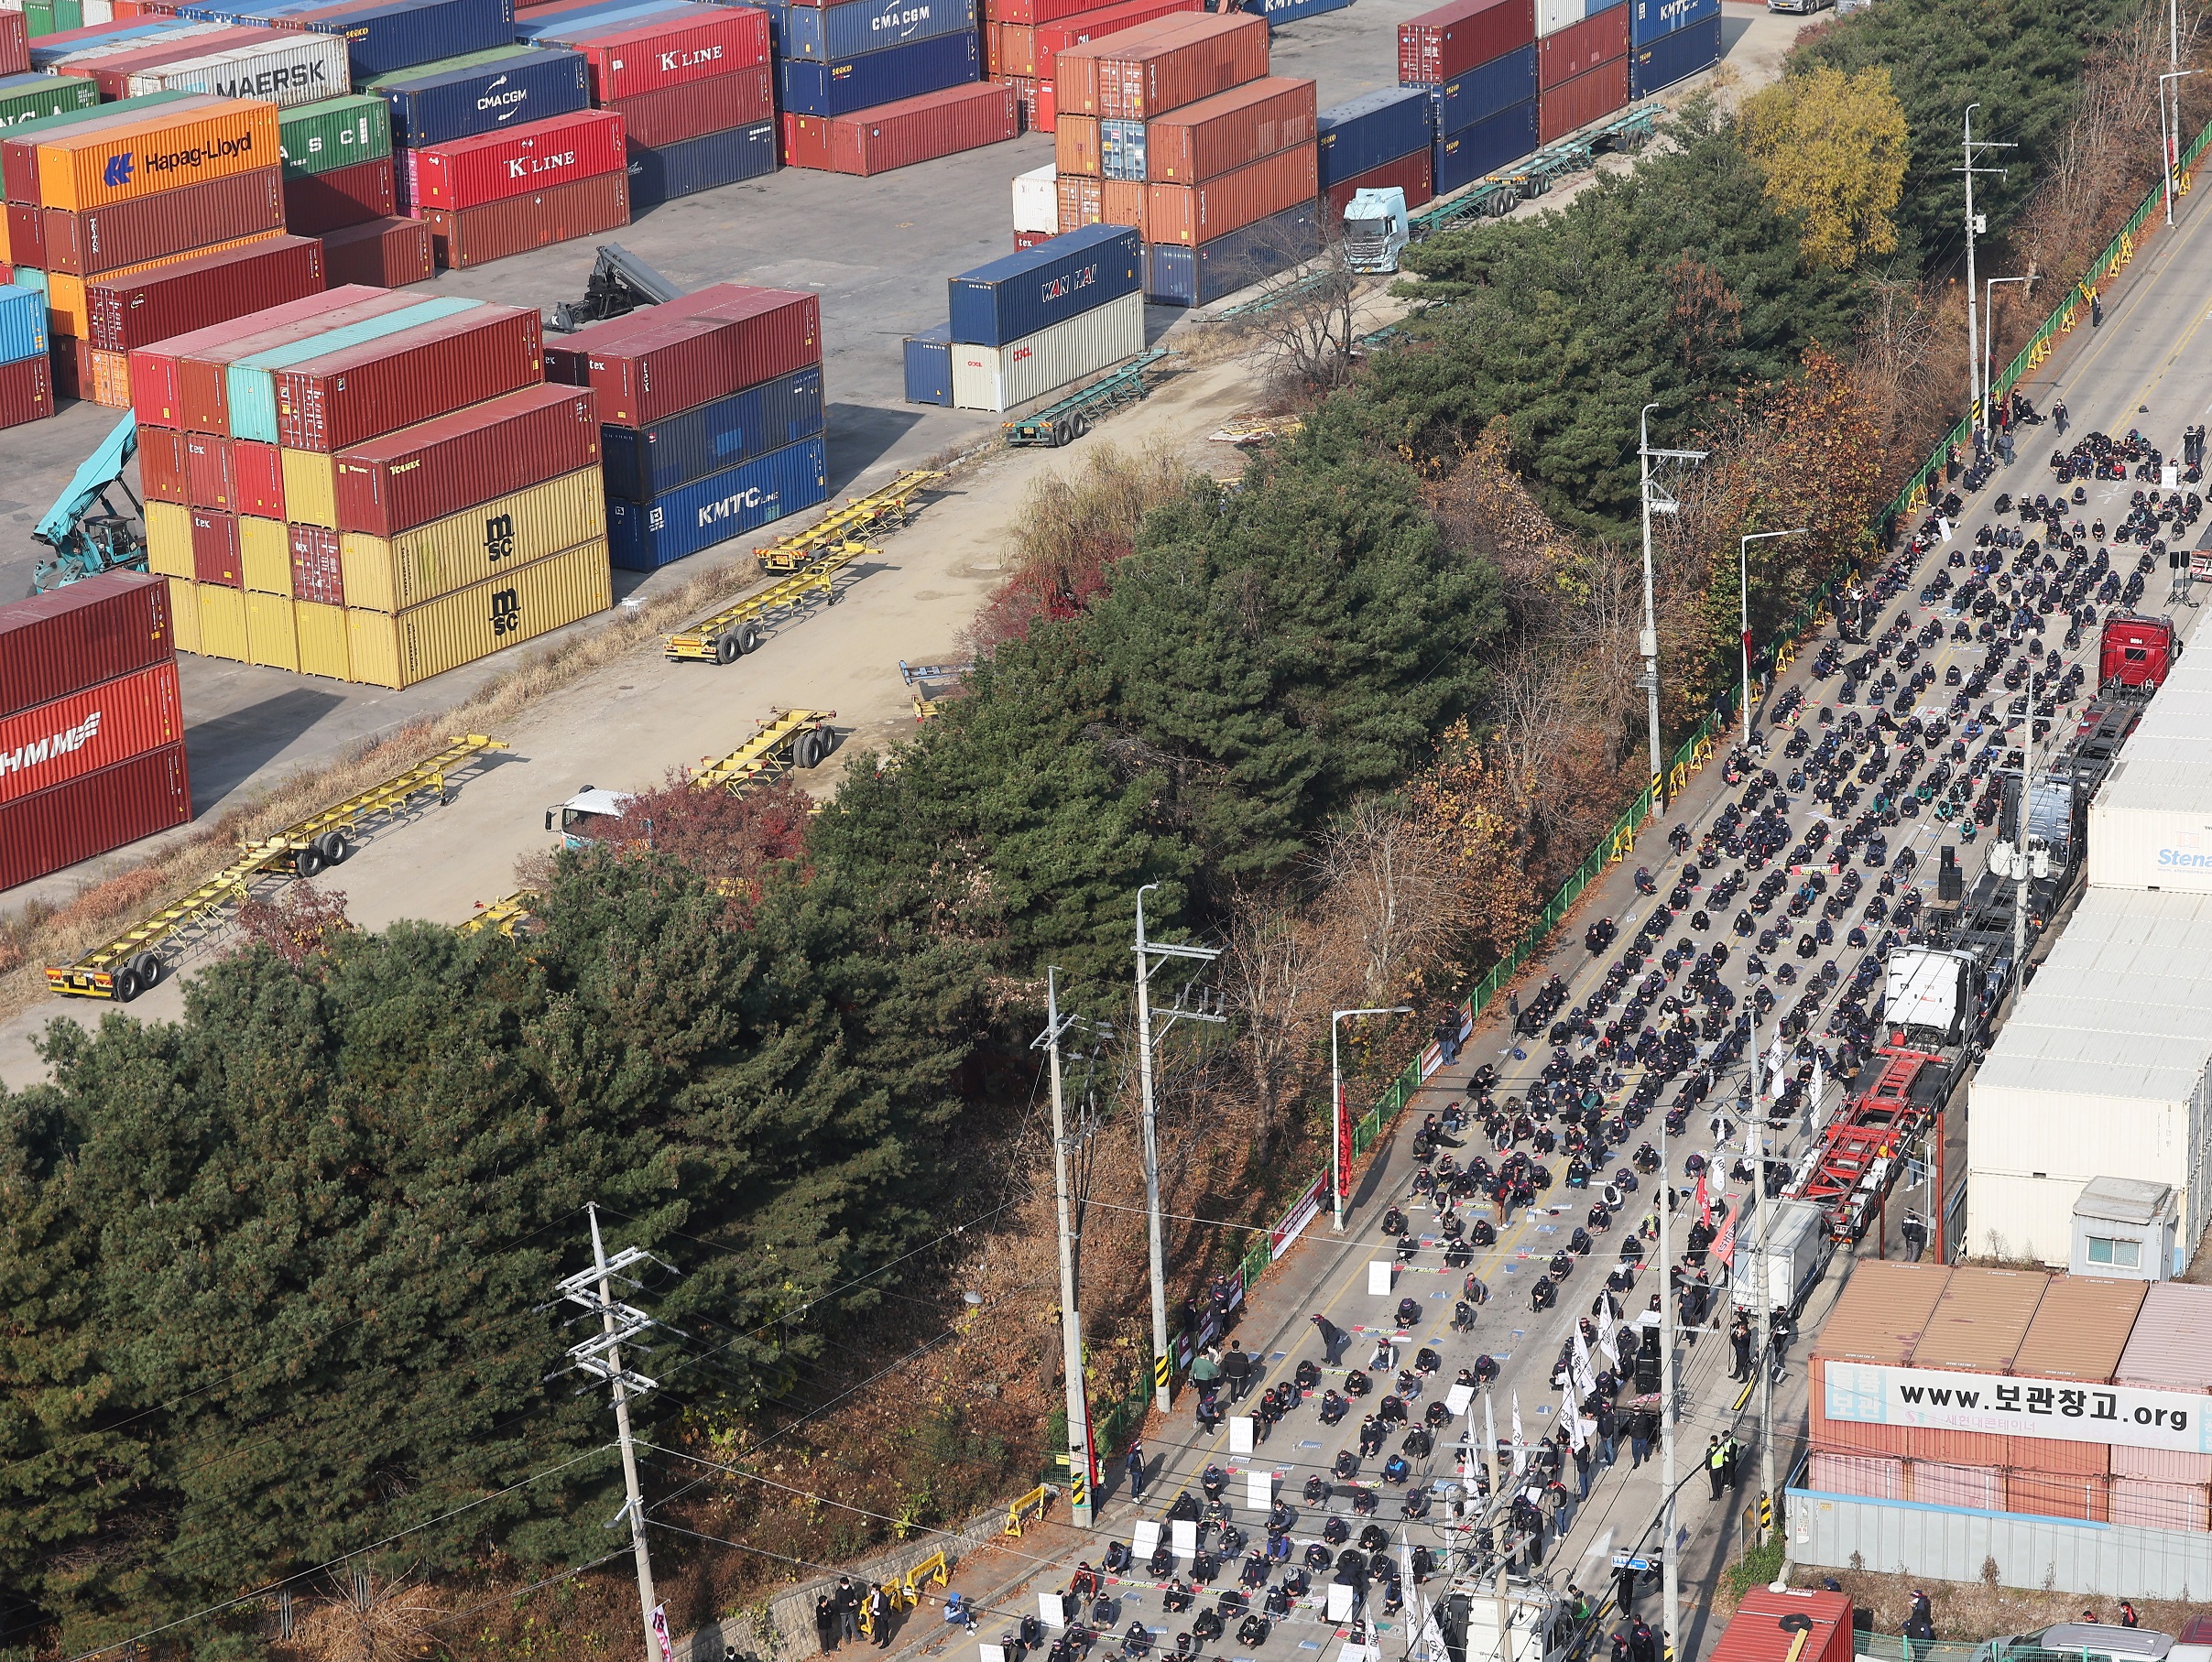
336,385,599,537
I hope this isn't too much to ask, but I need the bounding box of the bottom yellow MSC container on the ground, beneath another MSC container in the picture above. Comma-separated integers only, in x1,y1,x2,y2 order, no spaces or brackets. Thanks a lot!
345,537,615,688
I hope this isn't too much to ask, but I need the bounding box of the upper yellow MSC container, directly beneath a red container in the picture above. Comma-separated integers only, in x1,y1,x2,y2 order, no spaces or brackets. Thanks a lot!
333,466,606,618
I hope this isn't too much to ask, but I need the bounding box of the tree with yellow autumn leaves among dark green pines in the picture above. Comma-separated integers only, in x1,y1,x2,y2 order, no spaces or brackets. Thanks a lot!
1743,64,1907,269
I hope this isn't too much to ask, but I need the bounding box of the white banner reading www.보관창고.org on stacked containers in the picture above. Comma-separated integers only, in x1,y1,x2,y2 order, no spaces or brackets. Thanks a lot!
1823,1362,2212,1454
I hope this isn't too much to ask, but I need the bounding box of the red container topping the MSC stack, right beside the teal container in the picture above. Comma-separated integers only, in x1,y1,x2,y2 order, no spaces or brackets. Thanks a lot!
272,305,544,455
